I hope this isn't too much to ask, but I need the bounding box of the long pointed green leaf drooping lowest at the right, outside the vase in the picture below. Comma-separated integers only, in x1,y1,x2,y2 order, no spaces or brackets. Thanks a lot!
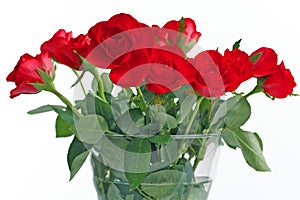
226,128,270,171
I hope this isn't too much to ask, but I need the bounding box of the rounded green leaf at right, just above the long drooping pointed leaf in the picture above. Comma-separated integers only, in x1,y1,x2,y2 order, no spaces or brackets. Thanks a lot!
225,96,251,129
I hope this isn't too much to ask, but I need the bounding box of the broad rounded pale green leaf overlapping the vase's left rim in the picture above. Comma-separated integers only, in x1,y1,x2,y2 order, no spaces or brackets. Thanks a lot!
73,114,108,144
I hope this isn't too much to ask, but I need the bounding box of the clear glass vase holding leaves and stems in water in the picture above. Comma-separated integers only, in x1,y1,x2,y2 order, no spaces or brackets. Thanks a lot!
91,134,220,200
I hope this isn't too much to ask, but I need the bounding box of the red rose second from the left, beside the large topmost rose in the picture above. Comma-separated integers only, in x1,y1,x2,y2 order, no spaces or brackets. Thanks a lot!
41,29,90,70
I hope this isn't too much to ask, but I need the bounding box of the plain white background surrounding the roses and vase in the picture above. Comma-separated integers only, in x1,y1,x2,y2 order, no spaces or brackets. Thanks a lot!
0,0,300,200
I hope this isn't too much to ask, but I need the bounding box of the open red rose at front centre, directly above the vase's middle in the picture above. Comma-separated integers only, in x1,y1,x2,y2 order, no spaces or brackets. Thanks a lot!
145,45,195,94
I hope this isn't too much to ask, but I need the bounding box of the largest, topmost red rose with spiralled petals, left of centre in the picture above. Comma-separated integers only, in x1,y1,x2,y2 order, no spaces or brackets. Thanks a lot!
87,13,148,68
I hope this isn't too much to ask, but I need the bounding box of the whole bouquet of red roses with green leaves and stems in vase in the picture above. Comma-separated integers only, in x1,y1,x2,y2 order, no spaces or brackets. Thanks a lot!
7,14,296,200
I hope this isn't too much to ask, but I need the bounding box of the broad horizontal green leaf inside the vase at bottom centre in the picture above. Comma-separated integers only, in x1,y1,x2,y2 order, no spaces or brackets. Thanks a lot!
141,170,186,199
